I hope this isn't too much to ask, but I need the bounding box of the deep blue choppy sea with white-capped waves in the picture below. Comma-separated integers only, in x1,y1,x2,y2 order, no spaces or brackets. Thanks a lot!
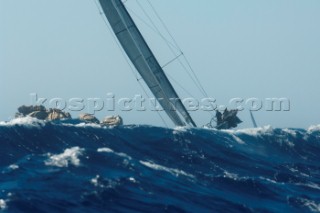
0,118,320,212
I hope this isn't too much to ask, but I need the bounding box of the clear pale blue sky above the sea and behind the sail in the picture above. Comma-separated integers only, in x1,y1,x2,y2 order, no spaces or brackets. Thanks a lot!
0,0,320,128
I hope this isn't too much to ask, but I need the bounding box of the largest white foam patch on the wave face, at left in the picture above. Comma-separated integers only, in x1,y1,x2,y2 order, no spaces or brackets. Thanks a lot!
45,147,84,167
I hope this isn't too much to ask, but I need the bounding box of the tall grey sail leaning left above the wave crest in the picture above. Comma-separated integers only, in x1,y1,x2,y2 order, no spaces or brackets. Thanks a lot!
99,0,196,127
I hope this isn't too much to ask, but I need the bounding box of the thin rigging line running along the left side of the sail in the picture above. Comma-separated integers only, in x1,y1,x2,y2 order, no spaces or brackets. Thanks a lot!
93,0,169,128
